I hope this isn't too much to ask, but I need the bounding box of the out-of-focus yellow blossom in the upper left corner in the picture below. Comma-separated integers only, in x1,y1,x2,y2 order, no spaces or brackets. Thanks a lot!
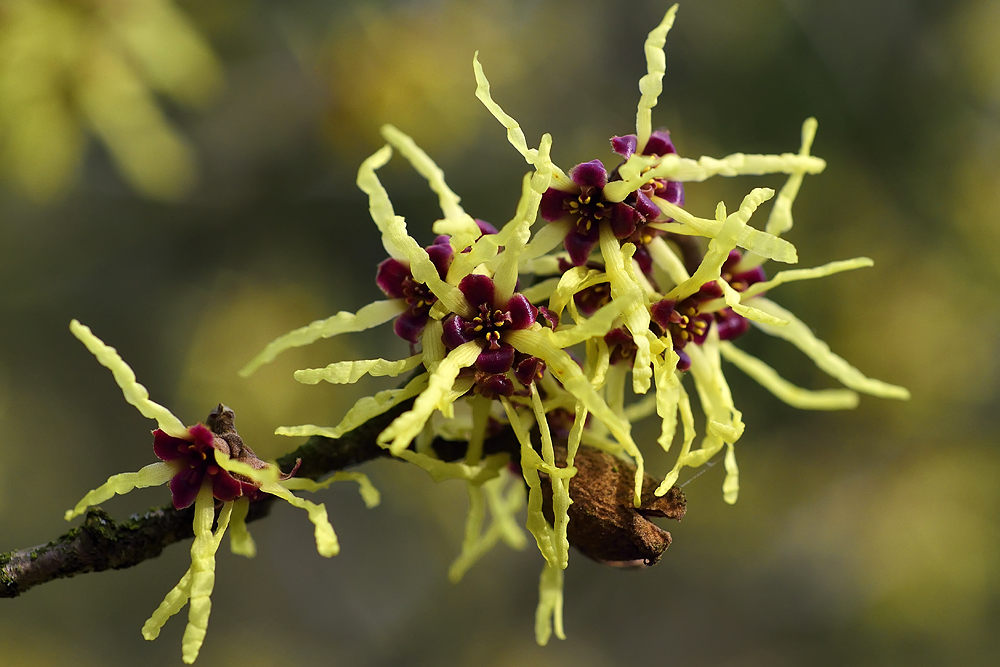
0,0,221,201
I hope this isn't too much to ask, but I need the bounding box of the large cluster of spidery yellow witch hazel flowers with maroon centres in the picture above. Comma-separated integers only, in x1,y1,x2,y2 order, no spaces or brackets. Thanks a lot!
241,6,908,644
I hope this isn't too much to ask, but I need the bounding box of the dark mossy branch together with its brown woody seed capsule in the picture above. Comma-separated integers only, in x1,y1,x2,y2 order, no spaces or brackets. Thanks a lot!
0,400,686,598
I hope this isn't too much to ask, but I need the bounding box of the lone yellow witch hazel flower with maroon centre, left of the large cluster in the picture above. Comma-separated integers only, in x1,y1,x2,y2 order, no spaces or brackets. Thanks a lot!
65,320,379,664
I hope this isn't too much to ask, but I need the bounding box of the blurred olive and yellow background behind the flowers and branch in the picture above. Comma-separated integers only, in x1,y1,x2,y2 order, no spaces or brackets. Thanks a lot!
0,0,1000,666
